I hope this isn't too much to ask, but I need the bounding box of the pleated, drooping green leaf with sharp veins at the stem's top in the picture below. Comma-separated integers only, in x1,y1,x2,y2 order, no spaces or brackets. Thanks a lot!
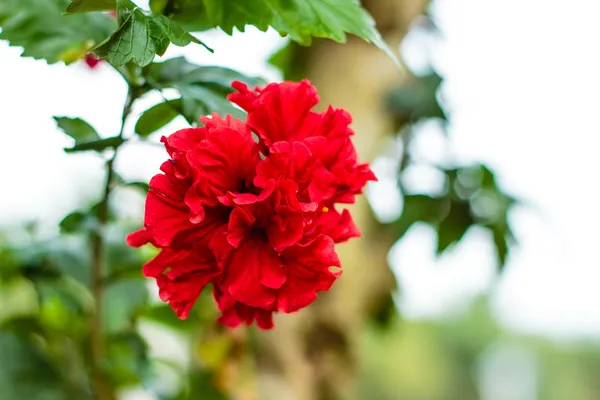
93,0,210,67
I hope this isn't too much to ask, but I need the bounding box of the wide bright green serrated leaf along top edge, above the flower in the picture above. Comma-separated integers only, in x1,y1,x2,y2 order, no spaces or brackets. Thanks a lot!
155,0,397,62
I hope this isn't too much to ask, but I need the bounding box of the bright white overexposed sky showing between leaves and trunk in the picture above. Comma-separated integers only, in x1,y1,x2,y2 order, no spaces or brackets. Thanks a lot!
0,0,600,336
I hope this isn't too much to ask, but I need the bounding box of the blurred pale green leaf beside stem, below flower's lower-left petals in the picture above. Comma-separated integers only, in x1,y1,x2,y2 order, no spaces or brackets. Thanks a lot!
102,279,148,333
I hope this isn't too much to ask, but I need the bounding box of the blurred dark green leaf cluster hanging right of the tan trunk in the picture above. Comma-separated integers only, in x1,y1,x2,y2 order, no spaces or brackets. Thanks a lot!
386,48,516,269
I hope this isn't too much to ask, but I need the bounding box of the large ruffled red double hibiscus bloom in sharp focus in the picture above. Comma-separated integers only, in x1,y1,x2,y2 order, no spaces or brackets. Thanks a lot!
127,80,376,329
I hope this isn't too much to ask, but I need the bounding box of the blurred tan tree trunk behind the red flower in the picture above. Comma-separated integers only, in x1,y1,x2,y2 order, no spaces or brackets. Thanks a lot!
257,0,427,400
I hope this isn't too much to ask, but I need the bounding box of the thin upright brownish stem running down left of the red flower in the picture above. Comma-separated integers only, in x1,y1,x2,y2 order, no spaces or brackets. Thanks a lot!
90,87,137,400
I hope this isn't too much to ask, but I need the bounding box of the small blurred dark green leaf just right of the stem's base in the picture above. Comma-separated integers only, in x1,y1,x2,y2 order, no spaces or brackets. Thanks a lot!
107,333,150,387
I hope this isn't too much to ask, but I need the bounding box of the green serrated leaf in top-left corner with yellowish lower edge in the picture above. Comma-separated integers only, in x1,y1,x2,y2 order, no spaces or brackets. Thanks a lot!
0,0,116,64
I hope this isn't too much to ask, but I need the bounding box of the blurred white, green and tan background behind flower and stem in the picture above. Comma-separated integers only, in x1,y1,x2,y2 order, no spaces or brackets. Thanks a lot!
0,0,600,400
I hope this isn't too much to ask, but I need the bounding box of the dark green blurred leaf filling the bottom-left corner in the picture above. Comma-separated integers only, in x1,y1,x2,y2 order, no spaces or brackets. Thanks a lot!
0,332,69,400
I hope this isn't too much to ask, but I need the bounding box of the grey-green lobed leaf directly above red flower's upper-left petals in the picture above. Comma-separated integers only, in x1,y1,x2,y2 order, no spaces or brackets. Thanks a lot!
147,57,264,122
